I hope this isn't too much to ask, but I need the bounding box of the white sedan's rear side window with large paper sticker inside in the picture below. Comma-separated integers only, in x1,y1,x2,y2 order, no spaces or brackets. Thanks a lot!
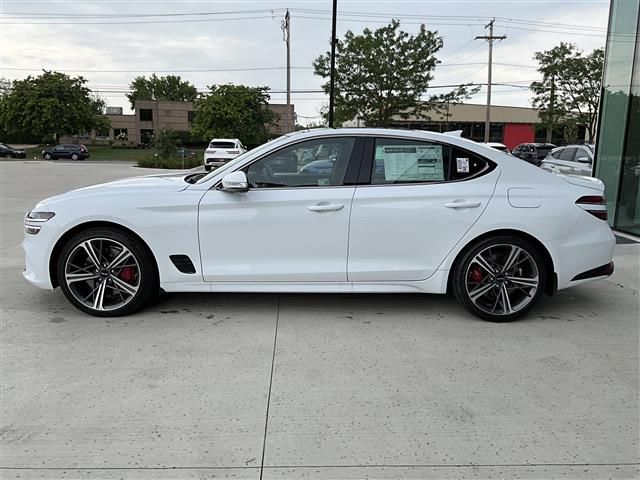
371,138,488,185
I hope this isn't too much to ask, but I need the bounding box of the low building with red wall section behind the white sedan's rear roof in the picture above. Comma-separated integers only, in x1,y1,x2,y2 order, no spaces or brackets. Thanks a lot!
384,103,585,149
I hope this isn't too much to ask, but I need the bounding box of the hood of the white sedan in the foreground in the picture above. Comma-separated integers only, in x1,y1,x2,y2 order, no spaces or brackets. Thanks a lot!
38,172,189,207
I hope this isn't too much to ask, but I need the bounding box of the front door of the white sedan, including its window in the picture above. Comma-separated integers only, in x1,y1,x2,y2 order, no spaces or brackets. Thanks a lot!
199,136,361,283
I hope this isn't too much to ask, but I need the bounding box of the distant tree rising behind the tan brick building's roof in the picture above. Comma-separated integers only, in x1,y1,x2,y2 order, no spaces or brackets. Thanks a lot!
127,73,198,108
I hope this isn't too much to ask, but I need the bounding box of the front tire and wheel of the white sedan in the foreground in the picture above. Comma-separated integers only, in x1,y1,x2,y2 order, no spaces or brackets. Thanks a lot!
56,228,158,317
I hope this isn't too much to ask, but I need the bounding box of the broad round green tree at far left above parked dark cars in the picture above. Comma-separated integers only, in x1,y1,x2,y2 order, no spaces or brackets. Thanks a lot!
0,70,109,141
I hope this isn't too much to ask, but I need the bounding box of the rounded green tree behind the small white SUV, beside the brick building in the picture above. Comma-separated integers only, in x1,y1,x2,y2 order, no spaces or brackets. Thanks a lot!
192,84,274,146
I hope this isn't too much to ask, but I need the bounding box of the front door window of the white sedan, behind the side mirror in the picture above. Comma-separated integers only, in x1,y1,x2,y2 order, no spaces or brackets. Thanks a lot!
245,137,355,188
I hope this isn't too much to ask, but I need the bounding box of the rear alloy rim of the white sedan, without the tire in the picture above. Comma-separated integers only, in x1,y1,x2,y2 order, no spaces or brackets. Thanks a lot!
465,243,540,316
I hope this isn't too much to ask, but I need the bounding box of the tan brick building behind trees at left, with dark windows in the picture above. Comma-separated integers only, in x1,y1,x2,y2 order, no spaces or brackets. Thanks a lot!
60,100,295,145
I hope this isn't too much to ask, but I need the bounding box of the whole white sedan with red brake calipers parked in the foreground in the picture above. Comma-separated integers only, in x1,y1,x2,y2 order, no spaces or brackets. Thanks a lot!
23,129,615,321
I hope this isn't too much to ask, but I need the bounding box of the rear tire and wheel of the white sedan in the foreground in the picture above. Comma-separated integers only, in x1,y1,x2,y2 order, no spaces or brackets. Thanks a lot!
453,235,547,322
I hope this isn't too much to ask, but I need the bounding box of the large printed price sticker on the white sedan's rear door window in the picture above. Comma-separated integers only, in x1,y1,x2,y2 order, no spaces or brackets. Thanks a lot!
376,145,444,182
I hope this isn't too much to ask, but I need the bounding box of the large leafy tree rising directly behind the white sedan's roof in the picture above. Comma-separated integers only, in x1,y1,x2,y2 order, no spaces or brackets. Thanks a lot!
313,20,477,127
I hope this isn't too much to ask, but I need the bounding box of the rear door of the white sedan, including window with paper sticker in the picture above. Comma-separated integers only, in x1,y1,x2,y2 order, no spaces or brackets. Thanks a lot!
348,138,499,282
